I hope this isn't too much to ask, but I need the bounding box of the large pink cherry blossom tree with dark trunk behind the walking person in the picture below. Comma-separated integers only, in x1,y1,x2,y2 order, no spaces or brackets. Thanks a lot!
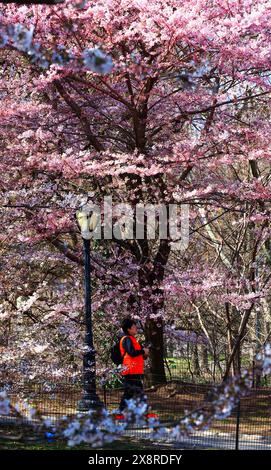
0,0,271,382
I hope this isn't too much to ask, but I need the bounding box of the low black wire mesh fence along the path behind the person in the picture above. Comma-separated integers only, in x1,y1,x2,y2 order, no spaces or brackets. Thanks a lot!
0,379,271,450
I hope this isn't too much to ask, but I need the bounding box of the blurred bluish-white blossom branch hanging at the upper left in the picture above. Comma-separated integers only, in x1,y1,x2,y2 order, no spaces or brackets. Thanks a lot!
0,22,113,74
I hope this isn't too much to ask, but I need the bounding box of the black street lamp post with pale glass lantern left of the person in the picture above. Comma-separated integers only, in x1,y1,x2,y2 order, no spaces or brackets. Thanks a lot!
76,205,103,411
